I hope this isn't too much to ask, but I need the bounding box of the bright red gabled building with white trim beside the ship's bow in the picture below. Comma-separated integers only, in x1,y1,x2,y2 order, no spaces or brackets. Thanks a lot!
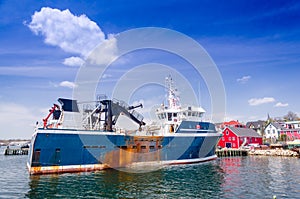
218,126,263,148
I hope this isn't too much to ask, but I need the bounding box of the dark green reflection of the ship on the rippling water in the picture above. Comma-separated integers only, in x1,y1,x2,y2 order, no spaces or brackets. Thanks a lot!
26,162,224,198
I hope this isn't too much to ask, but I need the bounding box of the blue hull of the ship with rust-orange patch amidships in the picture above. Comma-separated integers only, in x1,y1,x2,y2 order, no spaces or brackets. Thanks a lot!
27,124,220,174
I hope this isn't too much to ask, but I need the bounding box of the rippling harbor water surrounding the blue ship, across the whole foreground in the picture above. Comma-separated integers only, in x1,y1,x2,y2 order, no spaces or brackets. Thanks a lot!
0,147,300,199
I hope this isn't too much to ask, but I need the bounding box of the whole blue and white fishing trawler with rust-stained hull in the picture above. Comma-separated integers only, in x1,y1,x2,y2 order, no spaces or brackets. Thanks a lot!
27,76,221,174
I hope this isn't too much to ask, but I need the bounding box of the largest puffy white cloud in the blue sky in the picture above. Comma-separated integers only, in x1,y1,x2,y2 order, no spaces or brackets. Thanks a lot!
27,7,105,56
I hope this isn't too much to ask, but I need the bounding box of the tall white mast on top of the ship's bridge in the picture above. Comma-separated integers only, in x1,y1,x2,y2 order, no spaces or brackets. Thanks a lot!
166,75,181,109
